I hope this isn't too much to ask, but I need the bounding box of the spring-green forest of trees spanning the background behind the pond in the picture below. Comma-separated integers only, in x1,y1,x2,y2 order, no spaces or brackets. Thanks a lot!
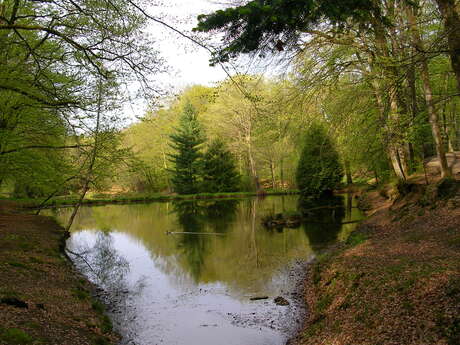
0,0,460,198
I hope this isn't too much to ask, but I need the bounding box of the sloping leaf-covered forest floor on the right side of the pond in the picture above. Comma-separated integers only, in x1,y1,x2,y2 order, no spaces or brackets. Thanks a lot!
292,179,460,345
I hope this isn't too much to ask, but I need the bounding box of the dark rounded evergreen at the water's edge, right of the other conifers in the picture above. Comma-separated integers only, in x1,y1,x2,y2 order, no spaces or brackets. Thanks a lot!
297,125,343,197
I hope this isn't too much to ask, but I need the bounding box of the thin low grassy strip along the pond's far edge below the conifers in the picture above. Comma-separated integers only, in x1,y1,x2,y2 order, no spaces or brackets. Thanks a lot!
3,190,298,208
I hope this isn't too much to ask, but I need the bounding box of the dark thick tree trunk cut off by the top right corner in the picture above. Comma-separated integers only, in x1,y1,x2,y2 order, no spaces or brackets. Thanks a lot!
436,0,460,91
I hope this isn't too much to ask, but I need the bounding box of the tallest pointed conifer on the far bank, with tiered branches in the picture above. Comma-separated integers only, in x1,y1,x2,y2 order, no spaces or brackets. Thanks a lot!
170,103,205,194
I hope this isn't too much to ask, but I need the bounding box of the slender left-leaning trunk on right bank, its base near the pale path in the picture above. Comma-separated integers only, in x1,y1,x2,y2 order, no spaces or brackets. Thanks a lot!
406,7,452,178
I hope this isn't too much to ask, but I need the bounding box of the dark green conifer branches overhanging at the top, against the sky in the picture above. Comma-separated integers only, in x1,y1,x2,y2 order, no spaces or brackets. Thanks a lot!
194,0,380,63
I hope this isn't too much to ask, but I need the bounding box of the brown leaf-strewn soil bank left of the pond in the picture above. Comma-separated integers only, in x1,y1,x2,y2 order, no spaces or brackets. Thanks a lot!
0,202,117,345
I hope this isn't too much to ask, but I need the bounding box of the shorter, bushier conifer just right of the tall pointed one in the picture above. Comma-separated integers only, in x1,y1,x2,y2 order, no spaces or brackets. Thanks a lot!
203,139,240,193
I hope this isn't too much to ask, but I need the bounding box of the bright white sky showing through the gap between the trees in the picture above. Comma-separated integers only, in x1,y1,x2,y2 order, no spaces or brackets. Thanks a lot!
123,0,227,123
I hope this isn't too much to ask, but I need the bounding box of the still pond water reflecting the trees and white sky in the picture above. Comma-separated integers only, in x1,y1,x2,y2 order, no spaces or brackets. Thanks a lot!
52,196,361,345
